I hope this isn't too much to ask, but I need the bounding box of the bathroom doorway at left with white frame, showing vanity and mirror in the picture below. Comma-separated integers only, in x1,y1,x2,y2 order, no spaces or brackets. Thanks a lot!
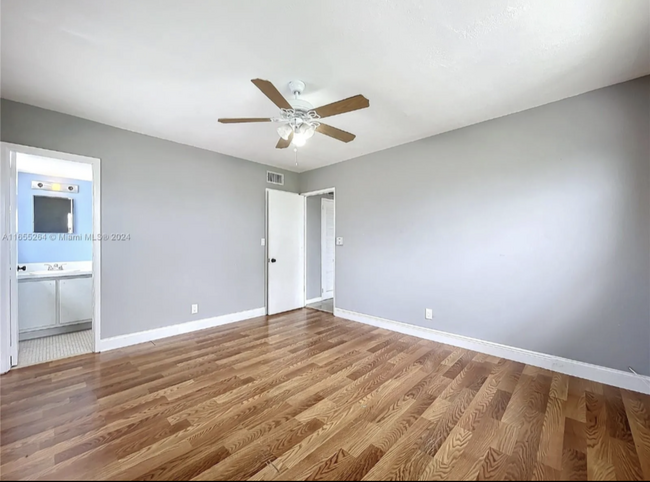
1,143,101,372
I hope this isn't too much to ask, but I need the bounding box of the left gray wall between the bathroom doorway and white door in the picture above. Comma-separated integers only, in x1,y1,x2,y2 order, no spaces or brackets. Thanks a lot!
0,100,298,338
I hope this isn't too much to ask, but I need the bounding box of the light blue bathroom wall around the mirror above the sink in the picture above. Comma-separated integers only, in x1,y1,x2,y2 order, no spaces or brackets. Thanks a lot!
16,172,93,263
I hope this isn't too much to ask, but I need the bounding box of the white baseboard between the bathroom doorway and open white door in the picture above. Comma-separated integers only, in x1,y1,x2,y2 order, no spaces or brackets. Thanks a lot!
98,308,266,351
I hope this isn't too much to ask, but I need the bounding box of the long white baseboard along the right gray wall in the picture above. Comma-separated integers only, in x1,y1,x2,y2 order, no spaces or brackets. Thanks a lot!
334,308,650,394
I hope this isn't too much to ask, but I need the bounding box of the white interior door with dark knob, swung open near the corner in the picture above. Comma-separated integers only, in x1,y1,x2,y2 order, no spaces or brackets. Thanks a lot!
266,189,305,315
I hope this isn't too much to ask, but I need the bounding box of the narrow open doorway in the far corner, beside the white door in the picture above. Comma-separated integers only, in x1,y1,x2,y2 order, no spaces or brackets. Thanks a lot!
305,190,336,313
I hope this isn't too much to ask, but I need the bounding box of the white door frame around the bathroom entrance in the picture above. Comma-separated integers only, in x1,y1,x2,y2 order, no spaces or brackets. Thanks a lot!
0,142,102,373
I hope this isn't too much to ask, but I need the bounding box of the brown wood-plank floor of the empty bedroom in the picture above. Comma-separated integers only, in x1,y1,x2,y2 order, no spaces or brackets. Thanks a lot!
0,310,650,480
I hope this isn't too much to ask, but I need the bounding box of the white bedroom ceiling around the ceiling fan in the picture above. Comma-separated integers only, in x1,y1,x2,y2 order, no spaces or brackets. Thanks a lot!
1,0,650,171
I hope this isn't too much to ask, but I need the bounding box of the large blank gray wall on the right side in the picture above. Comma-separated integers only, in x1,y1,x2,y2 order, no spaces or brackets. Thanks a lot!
300,77,650,375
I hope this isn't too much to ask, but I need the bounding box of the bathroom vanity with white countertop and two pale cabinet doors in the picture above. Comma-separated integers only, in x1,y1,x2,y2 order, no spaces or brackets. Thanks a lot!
18,269,93,340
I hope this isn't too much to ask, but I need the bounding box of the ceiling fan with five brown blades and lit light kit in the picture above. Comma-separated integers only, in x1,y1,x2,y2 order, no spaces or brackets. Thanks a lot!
219,79,370,149
